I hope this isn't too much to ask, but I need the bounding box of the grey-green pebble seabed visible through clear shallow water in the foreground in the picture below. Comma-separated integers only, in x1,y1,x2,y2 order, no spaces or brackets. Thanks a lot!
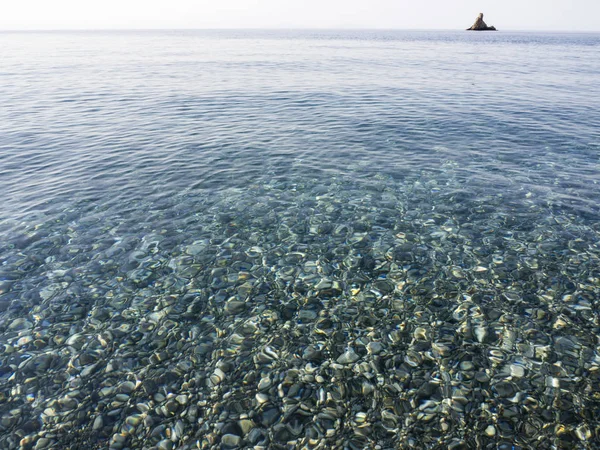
0,173,600,450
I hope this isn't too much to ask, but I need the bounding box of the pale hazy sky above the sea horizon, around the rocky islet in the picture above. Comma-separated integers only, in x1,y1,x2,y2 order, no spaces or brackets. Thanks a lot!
0,0,600,31
